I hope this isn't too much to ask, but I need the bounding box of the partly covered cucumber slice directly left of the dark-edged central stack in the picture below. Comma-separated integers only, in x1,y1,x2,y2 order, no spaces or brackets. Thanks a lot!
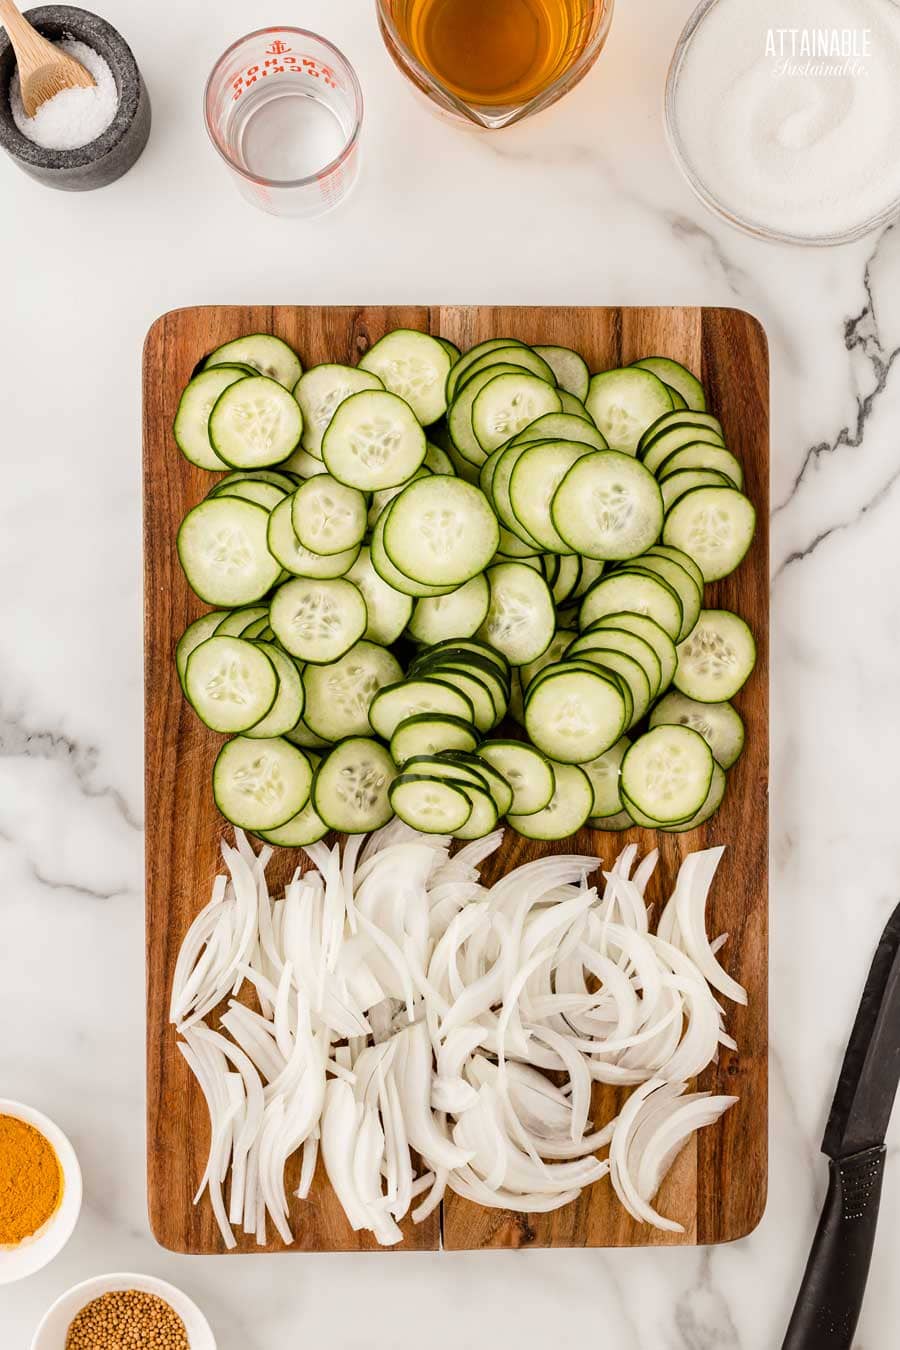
304,641,403,741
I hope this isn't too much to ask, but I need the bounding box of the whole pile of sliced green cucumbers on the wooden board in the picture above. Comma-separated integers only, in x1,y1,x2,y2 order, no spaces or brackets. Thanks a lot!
173,329,756,846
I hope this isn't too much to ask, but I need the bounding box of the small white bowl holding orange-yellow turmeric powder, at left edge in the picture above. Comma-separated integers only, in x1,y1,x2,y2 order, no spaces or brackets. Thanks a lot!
0,1098,81,1284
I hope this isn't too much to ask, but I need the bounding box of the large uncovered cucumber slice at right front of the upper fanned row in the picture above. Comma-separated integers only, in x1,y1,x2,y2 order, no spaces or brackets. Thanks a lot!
551,450,663,559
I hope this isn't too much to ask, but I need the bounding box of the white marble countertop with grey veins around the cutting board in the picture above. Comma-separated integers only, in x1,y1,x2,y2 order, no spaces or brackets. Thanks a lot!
0,0,900,1350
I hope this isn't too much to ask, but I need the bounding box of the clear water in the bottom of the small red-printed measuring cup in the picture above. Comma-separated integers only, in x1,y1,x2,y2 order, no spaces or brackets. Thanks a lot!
229,80,348,182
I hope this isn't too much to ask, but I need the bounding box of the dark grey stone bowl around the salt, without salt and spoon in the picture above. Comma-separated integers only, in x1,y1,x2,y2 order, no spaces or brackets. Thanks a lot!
0,4,150,192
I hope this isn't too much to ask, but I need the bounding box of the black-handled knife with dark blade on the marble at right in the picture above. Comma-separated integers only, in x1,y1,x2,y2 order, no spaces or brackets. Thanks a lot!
783,905,900,1350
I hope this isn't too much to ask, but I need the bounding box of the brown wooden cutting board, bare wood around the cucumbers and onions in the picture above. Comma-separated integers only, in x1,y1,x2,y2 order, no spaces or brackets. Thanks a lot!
143,305,769,1253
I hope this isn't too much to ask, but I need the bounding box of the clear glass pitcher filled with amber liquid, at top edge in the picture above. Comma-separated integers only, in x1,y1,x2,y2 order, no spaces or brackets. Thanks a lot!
375,0,614,130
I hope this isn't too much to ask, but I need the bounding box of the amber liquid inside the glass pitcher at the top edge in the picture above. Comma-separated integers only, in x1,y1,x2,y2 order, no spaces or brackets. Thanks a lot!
390,0,604,108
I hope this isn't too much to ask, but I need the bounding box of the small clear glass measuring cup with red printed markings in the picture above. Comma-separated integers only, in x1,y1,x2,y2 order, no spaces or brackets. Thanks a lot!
204,26,363,216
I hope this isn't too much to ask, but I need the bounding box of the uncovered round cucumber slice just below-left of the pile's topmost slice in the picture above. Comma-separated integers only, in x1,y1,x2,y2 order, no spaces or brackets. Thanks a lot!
322,389,425,493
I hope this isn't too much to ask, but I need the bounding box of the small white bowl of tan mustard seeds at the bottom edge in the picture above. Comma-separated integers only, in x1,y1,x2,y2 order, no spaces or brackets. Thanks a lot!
31,1274,216,1350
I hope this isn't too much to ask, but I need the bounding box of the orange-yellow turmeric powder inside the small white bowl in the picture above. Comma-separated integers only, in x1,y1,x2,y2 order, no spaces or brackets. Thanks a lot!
0,1115,62,1247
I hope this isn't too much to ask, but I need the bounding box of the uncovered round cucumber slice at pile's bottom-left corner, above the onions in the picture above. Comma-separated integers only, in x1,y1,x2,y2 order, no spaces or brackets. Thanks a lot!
212,736,313,833
